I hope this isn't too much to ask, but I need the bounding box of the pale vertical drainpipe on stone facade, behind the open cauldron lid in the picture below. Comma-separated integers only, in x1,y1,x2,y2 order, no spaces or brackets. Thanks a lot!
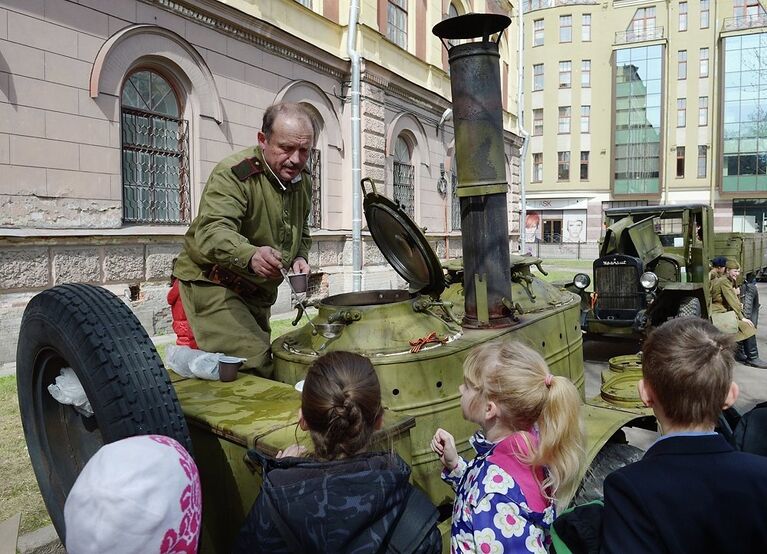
346,0,362,292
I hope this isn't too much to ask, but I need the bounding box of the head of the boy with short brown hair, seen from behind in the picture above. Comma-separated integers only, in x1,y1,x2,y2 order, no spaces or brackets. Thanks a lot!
642,317,735,425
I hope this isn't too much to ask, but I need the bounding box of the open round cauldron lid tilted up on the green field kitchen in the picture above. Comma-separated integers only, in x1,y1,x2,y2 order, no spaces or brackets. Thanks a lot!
361,177,445,297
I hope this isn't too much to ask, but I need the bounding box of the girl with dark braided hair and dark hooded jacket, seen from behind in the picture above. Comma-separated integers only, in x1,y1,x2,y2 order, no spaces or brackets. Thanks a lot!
234,351,442,554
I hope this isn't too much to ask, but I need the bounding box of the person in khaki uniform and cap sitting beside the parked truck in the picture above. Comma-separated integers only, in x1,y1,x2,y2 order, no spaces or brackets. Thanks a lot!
711,258,767,368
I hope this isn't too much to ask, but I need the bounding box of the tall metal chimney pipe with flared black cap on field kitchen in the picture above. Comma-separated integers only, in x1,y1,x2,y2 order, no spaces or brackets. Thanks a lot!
432,14,513,328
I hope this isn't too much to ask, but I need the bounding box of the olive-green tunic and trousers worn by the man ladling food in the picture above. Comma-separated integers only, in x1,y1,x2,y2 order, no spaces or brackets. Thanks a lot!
173,146,311,376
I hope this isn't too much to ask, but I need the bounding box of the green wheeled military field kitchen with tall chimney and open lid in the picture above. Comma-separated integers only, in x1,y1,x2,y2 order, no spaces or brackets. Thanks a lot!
17,14,649,553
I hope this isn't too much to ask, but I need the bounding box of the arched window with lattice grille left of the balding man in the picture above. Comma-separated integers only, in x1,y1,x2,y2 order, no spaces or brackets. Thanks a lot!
121,69,191,223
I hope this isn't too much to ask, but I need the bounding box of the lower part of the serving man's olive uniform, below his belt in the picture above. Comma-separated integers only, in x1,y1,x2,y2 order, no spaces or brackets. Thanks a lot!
179,281,272,377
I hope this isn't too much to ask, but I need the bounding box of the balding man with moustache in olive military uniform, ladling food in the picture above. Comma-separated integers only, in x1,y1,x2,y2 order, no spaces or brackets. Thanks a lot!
173,103,315,377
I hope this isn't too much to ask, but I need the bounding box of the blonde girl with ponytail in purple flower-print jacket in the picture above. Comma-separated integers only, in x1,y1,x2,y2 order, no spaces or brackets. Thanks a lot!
431,341,583,553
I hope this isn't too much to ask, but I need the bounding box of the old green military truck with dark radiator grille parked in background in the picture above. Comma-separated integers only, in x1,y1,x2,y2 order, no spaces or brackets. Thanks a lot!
573,204,767,339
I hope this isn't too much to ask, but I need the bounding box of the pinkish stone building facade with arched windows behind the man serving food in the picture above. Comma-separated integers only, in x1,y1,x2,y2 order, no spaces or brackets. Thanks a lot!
0,0,521,362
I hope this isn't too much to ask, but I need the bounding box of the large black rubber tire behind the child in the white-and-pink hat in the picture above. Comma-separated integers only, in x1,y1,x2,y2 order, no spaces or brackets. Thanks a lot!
16,284,192,540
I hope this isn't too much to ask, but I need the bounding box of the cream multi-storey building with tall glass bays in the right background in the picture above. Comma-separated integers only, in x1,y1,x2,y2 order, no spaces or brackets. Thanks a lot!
522,0,767,244
